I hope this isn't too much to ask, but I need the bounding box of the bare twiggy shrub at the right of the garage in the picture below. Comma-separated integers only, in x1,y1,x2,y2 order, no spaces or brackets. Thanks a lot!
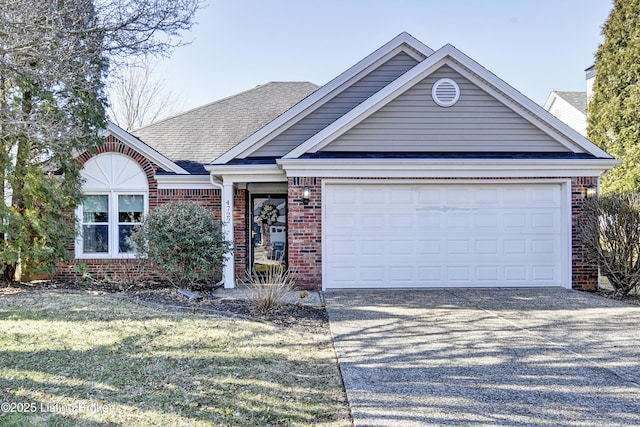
580,193,640,295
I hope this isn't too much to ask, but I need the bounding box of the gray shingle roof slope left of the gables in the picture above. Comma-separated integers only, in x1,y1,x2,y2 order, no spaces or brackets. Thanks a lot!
132,82,318,173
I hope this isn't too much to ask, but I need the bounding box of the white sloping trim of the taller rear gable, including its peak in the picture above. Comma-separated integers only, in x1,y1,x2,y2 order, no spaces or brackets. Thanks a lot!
213,33,434,164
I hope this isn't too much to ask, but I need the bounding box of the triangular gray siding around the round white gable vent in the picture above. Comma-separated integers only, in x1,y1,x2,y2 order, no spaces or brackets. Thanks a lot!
323,66,569,152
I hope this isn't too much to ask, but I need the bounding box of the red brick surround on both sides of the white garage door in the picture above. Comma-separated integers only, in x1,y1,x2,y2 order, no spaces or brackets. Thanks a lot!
288,177,598,291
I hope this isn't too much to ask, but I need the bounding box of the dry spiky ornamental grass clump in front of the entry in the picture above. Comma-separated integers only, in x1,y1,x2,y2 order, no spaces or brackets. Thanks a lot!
246,265,296,315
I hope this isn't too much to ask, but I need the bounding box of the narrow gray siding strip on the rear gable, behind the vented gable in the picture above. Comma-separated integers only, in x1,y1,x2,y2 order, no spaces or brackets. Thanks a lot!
251,52,418,157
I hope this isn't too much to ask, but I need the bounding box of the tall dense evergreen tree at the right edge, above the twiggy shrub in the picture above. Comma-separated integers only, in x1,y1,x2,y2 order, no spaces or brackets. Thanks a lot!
588,0,640,192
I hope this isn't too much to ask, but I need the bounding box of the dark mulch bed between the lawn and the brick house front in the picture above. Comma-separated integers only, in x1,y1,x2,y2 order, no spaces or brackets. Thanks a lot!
0,281,329,333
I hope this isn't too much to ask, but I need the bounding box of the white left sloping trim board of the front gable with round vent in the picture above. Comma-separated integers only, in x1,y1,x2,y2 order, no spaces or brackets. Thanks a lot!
282,48,456,159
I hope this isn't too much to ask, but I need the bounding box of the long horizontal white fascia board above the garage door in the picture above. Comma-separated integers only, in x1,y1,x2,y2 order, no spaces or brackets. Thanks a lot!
278,159,620,178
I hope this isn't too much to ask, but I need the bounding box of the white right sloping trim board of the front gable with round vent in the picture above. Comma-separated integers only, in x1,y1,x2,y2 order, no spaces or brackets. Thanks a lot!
440,45,612,158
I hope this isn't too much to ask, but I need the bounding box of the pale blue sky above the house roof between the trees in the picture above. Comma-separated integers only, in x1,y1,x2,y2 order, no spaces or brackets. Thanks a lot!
158,0,613,109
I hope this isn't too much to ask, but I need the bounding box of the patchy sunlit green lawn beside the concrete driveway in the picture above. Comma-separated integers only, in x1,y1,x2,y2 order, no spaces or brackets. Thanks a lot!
0,292,350,427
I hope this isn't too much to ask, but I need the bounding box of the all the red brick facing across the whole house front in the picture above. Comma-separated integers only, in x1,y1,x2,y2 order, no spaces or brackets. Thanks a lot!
62,136,598,291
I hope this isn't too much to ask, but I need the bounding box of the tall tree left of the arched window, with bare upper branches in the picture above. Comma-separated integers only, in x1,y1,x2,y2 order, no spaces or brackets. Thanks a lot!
0,0,200,279
